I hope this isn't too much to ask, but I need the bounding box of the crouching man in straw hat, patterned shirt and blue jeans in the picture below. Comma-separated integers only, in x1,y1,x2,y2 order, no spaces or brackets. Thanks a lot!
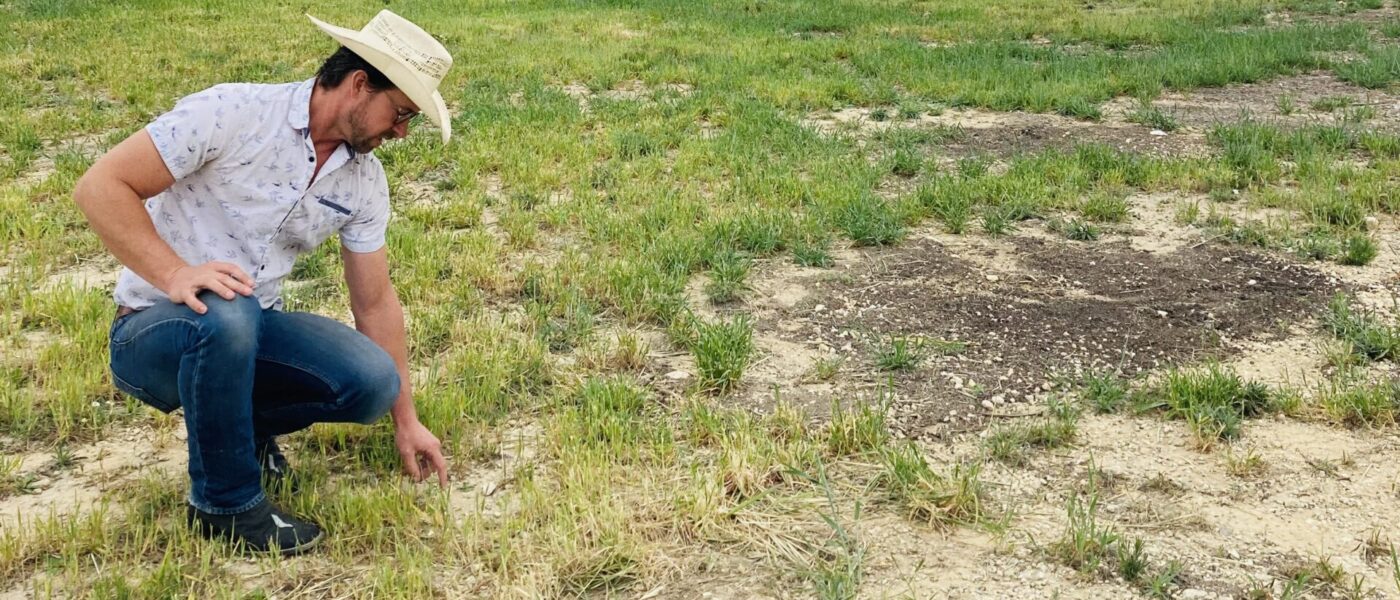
73,11,452,554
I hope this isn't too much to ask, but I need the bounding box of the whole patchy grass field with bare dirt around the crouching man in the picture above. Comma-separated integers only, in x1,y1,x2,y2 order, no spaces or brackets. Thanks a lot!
0,0,1400,599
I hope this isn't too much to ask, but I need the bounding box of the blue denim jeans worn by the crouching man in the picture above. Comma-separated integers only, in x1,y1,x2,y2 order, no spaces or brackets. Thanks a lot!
111,291,399,515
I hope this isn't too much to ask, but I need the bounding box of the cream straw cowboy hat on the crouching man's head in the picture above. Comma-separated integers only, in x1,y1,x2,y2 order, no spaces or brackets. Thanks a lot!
307,10,452,144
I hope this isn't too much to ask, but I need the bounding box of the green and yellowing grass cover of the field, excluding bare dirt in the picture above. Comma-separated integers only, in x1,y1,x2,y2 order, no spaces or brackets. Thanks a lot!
8,0,1400,599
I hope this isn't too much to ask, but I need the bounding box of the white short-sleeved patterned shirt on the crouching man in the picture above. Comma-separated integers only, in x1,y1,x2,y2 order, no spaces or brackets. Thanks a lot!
115,80,389,309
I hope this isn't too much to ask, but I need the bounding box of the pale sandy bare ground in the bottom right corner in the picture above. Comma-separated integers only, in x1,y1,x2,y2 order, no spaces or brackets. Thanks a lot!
858,417,1400,599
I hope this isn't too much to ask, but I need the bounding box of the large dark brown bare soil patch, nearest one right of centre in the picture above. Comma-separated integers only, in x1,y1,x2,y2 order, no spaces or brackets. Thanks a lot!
753,229,1340,436
